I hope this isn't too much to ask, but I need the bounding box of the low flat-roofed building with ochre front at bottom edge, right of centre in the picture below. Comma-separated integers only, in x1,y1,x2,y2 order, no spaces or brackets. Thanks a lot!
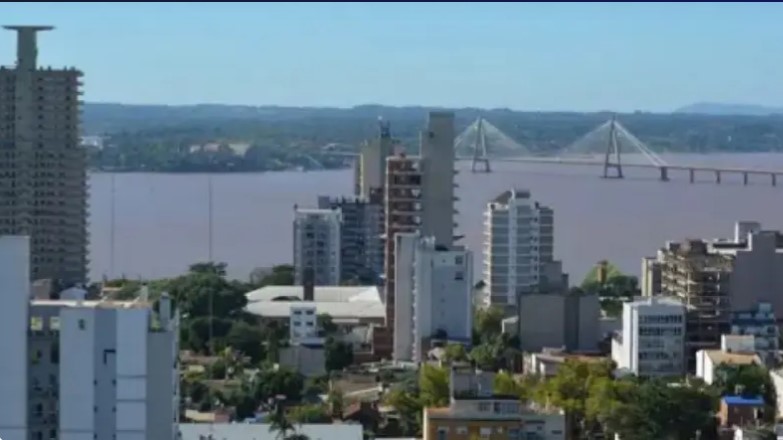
422,370,566,440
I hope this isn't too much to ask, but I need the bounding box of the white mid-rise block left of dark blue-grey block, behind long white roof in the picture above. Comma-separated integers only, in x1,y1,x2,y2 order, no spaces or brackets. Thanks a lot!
294,207,342,286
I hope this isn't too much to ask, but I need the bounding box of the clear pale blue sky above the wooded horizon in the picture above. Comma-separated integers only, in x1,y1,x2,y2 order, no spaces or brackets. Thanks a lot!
0,3,783,111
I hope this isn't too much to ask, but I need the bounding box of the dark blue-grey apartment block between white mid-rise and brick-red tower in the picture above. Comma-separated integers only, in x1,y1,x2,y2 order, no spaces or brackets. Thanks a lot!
318,190,384,285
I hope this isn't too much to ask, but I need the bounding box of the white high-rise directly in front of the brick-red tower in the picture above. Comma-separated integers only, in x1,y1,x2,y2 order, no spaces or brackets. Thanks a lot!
394,233,473,362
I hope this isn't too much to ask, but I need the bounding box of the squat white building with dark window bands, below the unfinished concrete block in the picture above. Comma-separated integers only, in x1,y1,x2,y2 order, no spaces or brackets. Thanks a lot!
612,297,686,376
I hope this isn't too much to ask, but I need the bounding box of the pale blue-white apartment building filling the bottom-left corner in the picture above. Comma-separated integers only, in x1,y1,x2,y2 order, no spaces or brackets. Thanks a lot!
0,236,179,440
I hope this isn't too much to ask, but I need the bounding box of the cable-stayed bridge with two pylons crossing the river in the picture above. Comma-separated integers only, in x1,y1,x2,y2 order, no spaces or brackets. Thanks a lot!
454,117,783,186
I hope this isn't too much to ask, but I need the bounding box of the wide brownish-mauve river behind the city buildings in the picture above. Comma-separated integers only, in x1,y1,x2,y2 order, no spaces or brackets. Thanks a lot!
90,154,783,283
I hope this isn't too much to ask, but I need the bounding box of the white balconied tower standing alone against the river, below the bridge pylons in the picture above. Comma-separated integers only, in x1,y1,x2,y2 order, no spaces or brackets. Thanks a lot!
484,189,563,306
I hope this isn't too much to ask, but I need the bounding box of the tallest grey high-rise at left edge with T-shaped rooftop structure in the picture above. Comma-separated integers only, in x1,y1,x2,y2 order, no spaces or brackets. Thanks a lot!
0,26,88,285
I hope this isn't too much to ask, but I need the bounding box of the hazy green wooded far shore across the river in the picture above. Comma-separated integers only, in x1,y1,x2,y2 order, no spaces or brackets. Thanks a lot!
84,104,783,172
